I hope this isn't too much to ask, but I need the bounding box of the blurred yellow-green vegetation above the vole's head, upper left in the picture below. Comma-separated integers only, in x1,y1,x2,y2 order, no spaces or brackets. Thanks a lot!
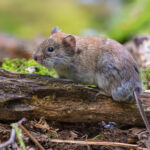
0,0,90,39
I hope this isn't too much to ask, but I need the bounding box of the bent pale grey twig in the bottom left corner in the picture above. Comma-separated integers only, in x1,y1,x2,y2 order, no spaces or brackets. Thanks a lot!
0,128,16,149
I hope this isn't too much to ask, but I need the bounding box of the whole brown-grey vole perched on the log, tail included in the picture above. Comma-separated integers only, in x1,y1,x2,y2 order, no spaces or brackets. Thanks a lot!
34,27,150,132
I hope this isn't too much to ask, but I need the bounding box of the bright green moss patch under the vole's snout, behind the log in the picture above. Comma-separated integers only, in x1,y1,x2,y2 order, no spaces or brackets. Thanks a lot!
1,58,57,77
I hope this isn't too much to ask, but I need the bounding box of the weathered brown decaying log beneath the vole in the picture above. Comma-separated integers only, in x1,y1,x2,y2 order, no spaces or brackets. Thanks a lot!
0,69,150,125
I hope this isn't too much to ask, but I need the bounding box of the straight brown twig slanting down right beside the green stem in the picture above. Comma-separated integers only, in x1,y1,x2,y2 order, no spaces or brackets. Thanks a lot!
18,123,45,150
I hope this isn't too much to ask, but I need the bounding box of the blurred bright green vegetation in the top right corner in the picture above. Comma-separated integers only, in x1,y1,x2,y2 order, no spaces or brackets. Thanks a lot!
107,0,150,42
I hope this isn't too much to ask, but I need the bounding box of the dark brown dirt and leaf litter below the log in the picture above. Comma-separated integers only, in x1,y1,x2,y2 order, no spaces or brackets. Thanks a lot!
0,118,148,150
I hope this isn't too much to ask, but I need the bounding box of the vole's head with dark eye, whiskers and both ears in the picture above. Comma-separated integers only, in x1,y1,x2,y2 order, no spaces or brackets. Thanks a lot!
33,27,76,69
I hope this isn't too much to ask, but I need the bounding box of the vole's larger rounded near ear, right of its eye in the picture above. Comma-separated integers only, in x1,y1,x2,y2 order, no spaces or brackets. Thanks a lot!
62,35,76,50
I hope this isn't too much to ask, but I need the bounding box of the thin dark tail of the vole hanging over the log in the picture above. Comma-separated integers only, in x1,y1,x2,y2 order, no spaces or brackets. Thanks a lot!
134,89,150,133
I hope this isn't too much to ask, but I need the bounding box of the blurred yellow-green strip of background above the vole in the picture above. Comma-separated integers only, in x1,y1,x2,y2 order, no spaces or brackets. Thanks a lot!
0,0,150,43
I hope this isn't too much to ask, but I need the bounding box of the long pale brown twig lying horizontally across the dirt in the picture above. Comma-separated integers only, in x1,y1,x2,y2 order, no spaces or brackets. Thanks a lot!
50,139,138,149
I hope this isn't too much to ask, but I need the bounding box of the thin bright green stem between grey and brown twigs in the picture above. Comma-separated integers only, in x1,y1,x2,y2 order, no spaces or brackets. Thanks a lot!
12,123,26,150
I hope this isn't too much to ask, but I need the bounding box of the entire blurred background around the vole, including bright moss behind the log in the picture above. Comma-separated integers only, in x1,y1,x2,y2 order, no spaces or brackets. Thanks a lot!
0,0,150,89
